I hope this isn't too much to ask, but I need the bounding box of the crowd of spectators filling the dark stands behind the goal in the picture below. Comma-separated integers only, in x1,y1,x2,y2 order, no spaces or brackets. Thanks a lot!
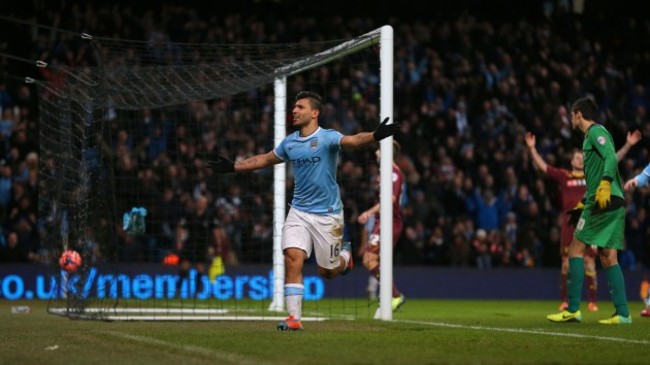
0,1,650,268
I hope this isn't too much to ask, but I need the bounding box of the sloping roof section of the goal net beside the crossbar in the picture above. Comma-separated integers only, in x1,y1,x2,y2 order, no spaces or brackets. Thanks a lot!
80,35,376,109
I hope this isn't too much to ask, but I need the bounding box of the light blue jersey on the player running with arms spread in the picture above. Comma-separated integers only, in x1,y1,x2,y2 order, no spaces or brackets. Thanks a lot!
273,127,343,214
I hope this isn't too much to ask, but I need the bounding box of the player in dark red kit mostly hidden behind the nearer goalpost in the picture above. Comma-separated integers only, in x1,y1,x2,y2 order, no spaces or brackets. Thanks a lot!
357,140,405,318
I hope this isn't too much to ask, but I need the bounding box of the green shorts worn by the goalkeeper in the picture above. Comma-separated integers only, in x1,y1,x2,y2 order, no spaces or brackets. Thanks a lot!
574,207,625,250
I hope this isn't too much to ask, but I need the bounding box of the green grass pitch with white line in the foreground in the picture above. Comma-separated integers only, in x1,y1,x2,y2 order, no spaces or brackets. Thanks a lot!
0,299,650,365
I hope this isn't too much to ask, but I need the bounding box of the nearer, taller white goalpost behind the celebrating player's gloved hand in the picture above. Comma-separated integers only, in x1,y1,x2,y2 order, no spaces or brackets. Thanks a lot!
379,25,395,321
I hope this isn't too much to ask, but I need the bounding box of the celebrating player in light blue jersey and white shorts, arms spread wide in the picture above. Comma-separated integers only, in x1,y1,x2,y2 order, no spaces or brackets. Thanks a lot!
207,91,399,331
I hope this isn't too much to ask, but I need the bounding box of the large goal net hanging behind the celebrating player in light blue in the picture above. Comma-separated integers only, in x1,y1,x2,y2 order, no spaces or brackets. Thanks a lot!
39,26,393,320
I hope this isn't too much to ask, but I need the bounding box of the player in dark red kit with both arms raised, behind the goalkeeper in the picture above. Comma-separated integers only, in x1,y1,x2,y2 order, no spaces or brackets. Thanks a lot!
525,130,641,312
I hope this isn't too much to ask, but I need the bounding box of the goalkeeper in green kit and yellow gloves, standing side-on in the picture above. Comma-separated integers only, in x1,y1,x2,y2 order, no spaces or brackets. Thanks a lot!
546,98,632,324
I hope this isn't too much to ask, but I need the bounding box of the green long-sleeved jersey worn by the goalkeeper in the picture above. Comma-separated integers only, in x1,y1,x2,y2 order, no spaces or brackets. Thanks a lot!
582,124,623,206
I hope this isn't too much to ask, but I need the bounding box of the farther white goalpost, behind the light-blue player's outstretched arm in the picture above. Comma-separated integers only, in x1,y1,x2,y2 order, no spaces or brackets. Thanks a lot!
269,77,287,312
